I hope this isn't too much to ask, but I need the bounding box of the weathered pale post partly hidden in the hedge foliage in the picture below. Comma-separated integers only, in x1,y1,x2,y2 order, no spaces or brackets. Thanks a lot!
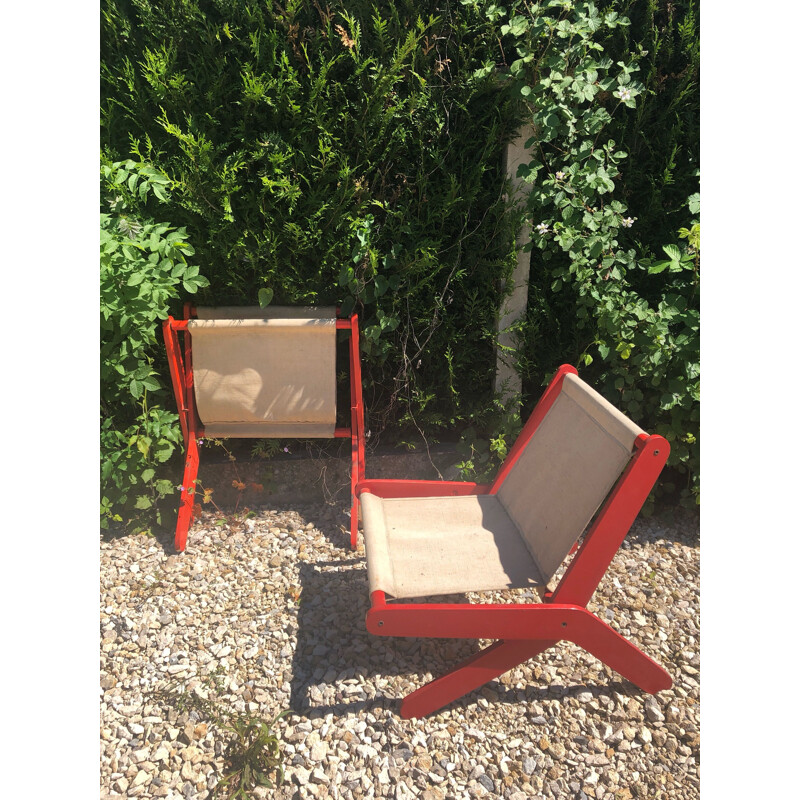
494,125,533,402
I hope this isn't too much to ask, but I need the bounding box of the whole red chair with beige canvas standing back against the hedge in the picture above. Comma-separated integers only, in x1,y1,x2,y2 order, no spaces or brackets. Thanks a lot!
163,303,364,551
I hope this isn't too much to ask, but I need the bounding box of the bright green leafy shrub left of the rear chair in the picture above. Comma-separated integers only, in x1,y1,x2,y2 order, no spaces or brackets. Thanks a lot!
100,160,208,529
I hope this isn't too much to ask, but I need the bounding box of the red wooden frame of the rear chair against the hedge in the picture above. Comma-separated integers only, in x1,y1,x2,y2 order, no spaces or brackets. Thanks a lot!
163,303,365,552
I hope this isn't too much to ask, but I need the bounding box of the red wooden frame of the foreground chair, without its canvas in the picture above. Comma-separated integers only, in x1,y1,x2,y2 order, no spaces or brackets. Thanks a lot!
356,365,672,718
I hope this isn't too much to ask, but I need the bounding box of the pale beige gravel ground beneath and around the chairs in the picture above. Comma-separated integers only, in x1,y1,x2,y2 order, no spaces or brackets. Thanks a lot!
100,505,700,800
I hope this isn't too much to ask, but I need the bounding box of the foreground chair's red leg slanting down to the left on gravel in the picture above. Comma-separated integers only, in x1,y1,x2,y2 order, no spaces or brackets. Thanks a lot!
400,639,556,719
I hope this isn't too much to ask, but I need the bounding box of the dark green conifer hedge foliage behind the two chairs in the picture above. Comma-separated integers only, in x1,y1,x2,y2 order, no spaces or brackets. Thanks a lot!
101,0,699,532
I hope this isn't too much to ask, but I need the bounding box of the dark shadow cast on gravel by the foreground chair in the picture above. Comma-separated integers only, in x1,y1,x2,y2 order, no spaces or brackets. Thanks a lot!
289,557,642,719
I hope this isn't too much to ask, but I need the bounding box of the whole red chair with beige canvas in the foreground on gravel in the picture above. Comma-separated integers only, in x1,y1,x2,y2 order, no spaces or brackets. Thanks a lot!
356,365,672,718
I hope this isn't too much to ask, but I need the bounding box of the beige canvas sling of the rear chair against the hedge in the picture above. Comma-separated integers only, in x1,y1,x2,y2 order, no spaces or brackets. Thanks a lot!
188,306,336,438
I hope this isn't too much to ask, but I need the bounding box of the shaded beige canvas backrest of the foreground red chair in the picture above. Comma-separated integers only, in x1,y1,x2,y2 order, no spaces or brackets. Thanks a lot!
497,373,644,581
